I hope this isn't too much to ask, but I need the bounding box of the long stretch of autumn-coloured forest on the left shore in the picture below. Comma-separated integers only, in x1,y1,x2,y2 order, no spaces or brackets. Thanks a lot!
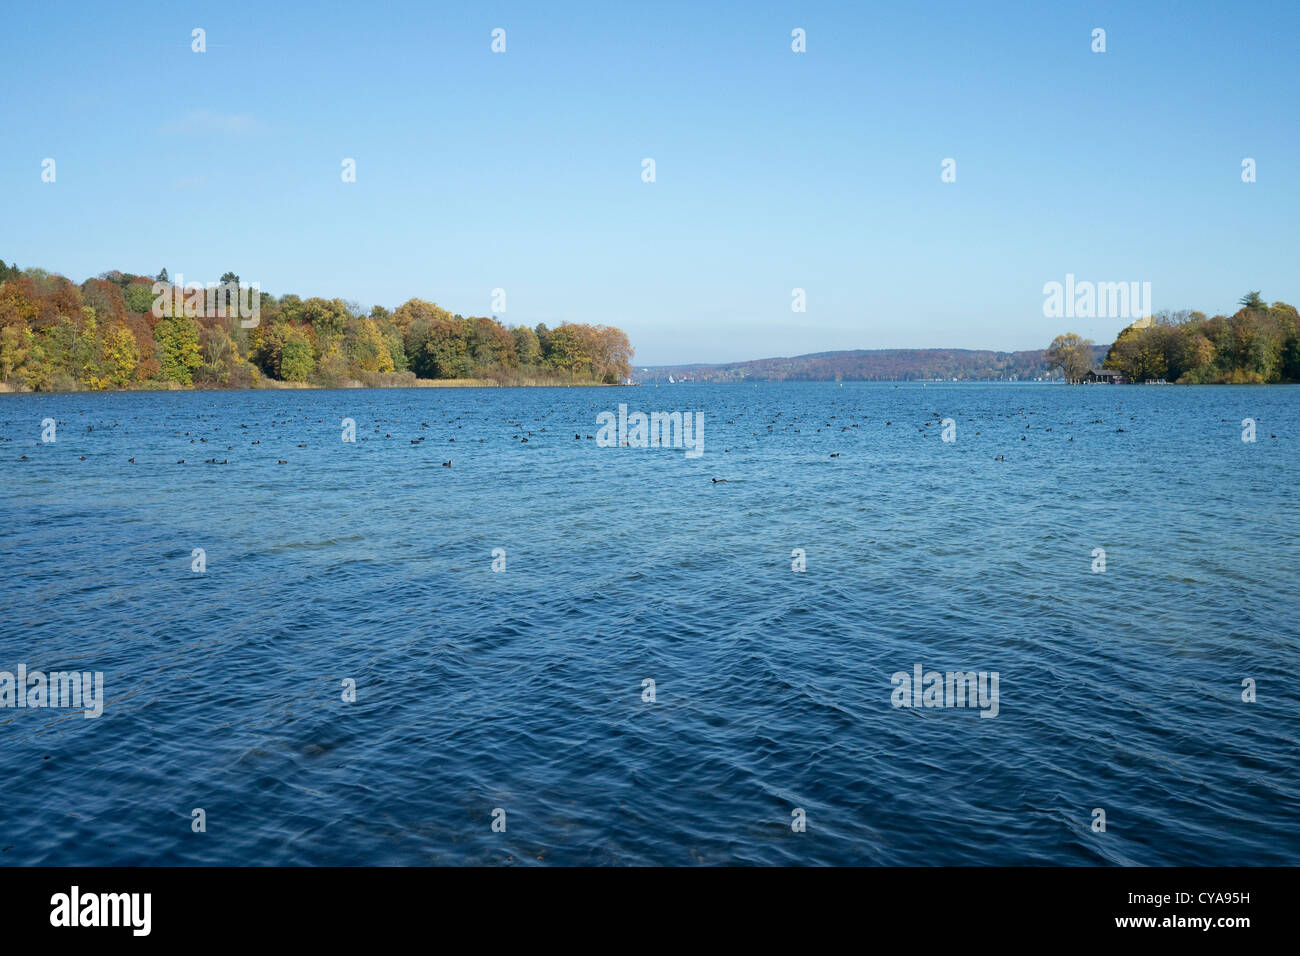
0,260,633,392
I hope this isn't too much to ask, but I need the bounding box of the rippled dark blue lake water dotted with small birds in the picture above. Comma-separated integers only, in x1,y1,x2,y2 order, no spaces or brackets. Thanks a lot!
0,384,1300,865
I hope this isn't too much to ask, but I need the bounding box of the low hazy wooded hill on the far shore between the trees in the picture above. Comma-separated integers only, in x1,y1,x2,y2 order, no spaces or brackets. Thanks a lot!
632,345,1110,382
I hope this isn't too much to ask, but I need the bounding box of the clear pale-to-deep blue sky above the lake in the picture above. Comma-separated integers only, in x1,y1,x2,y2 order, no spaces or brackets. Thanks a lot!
0,0,1300,364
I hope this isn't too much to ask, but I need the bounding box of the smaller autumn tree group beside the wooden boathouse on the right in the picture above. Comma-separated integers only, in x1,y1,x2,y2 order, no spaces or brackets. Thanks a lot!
1047,291,1300,385
